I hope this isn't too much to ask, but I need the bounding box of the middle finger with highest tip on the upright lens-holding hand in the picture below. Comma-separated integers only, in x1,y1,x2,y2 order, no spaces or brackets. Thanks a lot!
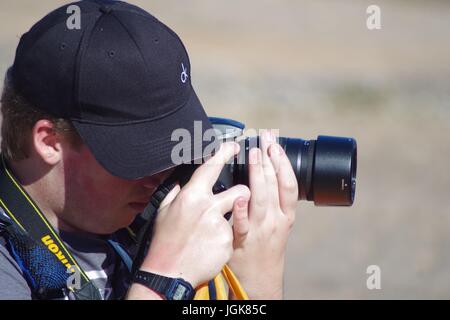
261,130,279,204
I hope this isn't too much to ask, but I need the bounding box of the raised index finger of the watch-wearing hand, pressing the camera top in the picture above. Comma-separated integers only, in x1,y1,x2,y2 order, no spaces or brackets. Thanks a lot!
187,142,240,191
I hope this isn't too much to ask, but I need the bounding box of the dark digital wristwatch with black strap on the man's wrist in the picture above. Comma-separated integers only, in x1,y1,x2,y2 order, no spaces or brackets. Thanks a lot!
133,270,195,300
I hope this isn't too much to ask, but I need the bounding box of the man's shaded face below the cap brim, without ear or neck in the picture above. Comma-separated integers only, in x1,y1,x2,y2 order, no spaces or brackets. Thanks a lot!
59,145,172,234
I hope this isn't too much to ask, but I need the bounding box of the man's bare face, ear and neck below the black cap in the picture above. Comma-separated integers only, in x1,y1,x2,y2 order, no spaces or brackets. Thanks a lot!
10,120,172,234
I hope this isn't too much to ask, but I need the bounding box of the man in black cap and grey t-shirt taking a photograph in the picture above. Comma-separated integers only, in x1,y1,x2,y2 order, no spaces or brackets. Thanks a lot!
0,0,298,299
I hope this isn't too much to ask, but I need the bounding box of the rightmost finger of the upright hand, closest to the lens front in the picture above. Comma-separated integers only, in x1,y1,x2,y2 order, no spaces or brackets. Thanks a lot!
270,144,298,218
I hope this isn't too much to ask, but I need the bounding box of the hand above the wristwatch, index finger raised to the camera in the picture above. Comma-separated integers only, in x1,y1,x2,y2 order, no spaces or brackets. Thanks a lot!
141,143,250,287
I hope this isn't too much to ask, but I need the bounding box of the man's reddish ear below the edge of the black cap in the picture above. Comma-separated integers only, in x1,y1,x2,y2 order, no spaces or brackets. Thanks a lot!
31,120,62,165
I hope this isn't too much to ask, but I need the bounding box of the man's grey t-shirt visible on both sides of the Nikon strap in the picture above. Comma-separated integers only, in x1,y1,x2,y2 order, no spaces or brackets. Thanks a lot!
0,231,134,300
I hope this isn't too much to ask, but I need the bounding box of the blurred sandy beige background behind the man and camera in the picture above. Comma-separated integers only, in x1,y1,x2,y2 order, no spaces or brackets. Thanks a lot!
0,0,450,299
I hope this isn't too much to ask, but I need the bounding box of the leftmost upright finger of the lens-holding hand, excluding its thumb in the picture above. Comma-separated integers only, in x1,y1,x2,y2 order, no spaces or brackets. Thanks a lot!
249,148,268,221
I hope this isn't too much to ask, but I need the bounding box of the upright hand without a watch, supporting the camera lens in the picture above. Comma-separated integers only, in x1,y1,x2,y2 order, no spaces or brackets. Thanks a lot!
229,131,298,299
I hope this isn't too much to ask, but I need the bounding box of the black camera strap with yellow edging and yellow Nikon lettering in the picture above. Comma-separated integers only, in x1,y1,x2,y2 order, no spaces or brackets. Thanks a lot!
0,155,102,300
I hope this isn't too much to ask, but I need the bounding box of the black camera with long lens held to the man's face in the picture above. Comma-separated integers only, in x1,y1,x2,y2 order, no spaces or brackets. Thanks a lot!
209,117,357,206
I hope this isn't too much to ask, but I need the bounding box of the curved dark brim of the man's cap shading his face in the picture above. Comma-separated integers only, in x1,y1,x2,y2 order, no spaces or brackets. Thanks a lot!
72,91,218,179
